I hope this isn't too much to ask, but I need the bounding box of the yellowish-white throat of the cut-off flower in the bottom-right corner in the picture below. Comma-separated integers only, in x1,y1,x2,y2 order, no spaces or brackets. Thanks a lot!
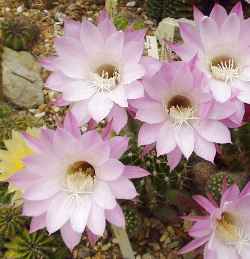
216,212,250,255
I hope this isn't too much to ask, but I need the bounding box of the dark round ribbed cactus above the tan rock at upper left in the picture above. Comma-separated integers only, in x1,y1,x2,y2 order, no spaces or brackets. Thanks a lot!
1,18,39,51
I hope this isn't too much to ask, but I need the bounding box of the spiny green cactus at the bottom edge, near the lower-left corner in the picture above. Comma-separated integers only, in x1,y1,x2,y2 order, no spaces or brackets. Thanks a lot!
5,229,56,259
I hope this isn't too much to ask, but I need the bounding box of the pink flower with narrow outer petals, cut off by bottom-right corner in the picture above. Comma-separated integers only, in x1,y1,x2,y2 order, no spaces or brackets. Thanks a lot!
180,183,250,259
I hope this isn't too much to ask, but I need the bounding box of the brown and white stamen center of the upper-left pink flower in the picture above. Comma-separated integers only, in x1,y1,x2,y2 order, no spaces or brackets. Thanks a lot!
94,64,121,93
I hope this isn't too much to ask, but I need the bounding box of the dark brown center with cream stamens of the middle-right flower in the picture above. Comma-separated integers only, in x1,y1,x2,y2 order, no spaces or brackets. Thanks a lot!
164,95,198,127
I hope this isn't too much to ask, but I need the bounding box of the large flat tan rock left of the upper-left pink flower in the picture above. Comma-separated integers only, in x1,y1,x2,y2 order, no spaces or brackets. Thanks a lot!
2,48,44,108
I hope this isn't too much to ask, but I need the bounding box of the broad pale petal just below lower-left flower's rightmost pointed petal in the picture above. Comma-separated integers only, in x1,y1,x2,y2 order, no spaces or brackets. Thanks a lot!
108,176,137,200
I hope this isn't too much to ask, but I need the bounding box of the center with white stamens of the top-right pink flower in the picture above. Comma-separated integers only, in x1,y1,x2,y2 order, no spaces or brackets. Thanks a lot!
210,56,240,83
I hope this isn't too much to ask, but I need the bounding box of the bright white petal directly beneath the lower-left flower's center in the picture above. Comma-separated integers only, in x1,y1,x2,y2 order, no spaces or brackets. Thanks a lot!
70,195,92,233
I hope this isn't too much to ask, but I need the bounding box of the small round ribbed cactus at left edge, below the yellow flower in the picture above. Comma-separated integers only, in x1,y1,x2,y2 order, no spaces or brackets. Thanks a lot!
0,207,25,239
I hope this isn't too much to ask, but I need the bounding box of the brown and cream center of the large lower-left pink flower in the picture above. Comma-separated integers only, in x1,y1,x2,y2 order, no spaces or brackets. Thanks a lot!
64,161,95,194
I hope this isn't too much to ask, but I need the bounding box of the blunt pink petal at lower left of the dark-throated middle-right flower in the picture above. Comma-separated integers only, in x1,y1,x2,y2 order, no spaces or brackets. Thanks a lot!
138,123,162,146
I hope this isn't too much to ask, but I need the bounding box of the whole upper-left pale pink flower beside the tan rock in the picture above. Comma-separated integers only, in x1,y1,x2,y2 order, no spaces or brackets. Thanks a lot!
41,12,145,132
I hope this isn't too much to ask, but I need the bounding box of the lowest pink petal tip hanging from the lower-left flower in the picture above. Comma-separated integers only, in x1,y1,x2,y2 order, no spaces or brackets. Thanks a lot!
61,222,82,251
